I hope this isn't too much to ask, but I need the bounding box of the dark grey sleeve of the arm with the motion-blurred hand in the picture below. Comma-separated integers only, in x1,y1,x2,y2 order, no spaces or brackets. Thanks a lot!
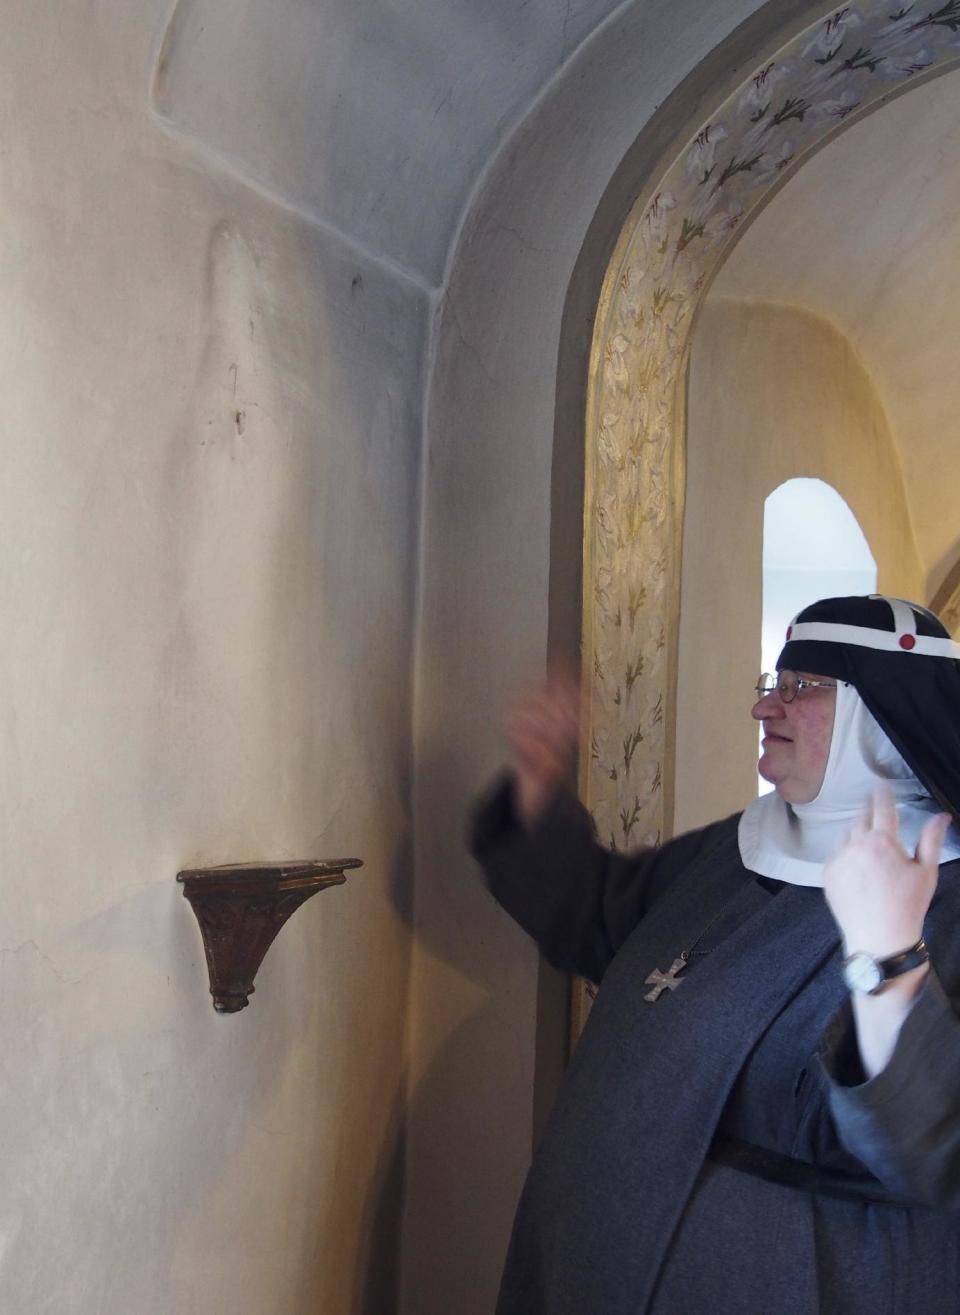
469,776,735,982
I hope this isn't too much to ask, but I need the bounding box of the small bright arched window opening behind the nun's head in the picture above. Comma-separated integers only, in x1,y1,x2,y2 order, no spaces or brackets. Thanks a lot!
757,479,877,794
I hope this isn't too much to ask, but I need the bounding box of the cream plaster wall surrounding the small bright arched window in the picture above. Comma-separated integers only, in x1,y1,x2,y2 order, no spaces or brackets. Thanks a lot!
675,298,923,831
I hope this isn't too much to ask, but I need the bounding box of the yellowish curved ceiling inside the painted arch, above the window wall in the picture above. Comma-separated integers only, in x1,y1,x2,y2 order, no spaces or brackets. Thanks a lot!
710,70,960,592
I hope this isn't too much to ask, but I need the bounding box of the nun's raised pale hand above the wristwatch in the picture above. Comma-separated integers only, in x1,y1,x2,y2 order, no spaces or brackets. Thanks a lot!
823,789,949,959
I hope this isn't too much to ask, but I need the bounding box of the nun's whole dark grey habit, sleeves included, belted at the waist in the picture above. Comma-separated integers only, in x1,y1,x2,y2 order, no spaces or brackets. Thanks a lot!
473,784,960,1315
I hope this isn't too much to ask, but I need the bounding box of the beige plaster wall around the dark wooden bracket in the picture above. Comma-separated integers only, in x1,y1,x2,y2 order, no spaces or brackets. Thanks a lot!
0,0,427,1315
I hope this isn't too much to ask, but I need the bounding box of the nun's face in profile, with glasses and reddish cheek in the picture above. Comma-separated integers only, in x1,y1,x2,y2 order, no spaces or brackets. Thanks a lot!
752,671,836,803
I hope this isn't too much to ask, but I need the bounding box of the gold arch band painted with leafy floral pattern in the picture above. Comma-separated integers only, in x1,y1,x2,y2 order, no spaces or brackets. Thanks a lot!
581,3,960,846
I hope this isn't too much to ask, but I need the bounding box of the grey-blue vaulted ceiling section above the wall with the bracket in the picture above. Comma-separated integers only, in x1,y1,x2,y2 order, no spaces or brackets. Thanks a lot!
154,0,618,287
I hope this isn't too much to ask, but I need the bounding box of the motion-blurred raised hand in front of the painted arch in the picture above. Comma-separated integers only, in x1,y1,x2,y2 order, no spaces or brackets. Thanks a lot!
506,665,580,827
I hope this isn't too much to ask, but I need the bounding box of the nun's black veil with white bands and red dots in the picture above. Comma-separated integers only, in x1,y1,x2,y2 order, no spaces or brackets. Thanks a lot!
777,594,960,821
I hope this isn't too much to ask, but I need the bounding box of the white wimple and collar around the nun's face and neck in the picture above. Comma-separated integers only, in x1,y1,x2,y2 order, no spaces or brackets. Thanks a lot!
738,682,960,886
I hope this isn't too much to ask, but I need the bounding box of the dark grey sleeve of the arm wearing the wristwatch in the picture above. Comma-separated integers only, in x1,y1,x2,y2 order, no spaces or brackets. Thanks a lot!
821,878,960,1208
